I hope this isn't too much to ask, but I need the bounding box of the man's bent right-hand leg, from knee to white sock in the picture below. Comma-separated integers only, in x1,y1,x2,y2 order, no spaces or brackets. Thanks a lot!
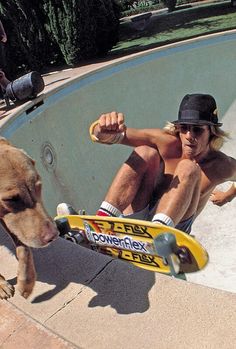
153,160,201,226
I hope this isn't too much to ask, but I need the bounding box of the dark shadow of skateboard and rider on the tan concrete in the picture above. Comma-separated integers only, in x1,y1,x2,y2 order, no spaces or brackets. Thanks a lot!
0,230,155,314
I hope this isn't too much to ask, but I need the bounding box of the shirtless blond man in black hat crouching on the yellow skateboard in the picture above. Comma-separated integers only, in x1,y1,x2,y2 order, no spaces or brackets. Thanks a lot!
90,94,236,233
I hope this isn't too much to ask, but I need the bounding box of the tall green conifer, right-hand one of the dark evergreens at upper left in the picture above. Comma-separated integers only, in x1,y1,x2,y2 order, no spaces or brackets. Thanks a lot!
44,0,119,65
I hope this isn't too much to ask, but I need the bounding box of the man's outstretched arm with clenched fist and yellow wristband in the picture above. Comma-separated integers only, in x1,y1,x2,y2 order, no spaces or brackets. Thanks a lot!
89,112,166,147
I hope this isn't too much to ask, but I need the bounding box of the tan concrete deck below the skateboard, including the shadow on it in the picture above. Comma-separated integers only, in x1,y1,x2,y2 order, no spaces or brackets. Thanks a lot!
1,228,236,349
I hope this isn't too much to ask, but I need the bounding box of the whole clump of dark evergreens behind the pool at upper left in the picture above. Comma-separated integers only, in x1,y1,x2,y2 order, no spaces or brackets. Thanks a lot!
0,0,120,77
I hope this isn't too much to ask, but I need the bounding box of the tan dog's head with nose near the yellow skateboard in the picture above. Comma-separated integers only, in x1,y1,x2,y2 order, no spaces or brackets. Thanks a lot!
0,138,58,247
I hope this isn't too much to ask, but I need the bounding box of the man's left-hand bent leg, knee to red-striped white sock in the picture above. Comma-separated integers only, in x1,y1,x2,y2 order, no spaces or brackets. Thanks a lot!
97,146,160,216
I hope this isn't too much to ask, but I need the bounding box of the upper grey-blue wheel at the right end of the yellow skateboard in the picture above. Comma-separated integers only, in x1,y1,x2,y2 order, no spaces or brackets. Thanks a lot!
154,233,178,258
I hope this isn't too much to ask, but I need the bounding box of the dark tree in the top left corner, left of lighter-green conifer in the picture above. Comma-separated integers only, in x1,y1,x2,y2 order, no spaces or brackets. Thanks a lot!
0,0,60,75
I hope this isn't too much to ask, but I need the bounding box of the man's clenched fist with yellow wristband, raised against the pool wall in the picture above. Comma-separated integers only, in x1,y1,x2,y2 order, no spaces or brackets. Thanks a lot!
90,111,126,144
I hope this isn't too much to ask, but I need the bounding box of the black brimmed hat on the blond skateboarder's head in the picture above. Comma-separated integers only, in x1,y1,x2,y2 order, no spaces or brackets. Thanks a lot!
173,93,222,126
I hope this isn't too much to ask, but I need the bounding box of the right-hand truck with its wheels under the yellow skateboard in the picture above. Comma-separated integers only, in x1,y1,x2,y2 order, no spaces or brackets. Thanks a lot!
154,233,180,276
